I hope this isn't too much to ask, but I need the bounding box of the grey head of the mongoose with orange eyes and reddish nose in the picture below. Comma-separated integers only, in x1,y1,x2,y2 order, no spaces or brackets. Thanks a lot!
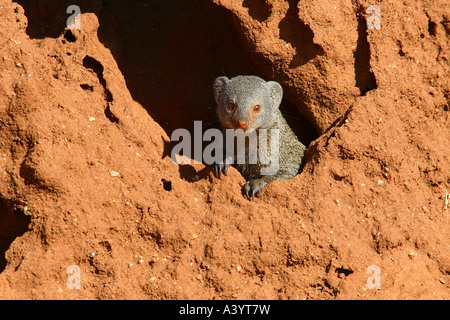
213,76,283,132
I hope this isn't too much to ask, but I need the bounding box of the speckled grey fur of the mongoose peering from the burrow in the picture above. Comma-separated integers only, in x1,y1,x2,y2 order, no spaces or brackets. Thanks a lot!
213,76,306,199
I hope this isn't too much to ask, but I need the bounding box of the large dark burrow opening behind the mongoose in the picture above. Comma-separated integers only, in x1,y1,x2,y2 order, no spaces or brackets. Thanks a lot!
17,0,317,150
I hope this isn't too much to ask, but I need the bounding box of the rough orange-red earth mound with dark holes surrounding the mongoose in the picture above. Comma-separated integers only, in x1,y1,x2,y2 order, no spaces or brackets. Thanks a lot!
0,0,450,299
